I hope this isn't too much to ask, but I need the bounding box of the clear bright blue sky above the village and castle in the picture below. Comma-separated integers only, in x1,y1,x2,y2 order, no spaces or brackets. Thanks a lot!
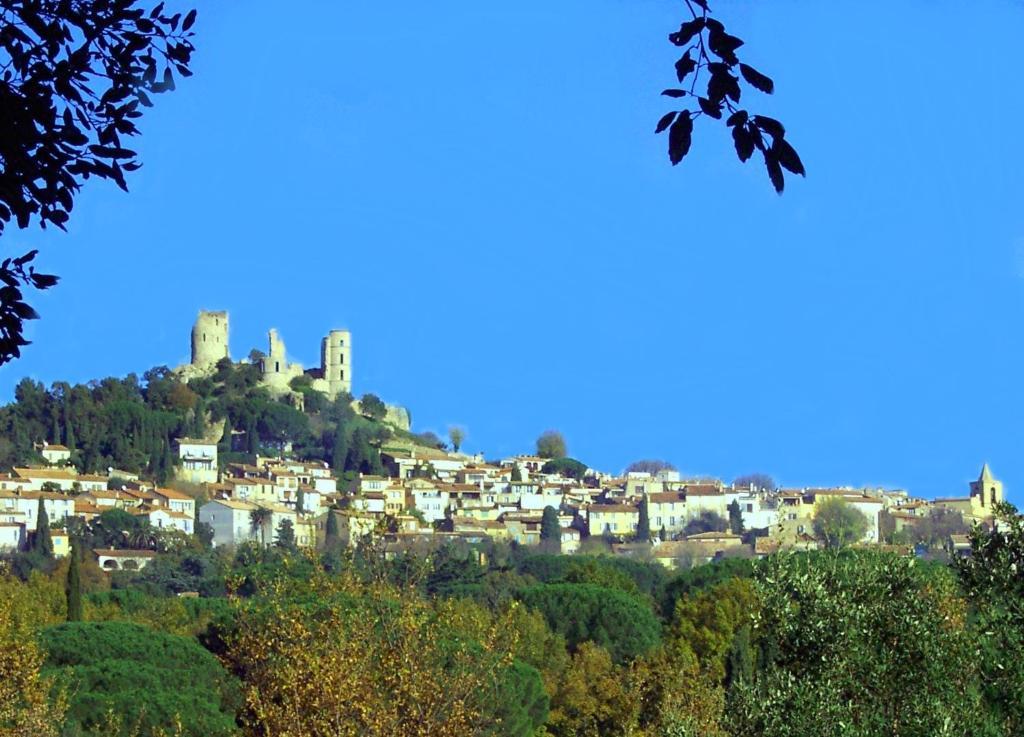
0,0,1024,500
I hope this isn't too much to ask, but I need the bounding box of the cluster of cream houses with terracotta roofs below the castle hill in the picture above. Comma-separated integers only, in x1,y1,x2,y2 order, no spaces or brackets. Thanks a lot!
0,431,1004,570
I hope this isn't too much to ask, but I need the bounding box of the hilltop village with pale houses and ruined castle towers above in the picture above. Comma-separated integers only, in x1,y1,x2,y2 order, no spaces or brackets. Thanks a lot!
0,312,1004,570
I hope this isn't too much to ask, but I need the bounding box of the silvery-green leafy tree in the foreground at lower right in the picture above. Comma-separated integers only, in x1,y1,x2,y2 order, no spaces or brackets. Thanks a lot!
728,551,987,737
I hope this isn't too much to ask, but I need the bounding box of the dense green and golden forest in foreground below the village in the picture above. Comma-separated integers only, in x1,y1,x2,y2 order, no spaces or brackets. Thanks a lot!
6,507,1024,737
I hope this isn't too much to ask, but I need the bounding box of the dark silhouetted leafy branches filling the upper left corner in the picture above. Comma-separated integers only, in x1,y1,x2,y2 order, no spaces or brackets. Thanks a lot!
0,0,196,364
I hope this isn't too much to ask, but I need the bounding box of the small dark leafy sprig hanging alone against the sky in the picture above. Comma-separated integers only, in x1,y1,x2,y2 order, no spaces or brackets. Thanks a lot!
654,0,805,193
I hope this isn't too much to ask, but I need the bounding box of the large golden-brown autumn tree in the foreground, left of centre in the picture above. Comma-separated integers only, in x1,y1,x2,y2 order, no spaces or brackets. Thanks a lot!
223,556,528,737
